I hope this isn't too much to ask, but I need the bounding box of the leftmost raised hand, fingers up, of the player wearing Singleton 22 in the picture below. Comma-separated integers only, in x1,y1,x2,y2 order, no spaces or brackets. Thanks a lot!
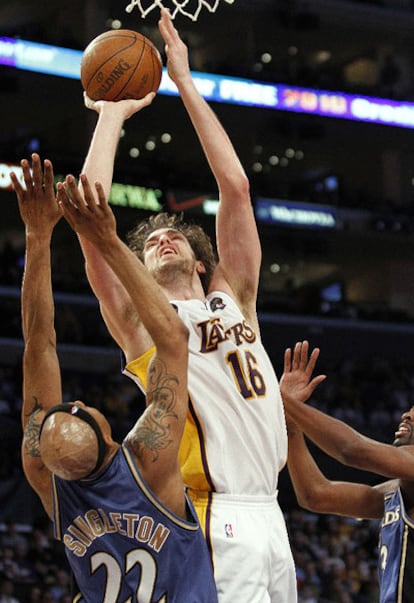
10,153,62,236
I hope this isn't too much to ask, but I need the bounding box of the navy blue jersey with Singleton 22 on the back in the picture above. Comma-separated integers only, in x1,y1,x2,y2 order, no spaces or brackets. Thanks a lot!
53,444,217,603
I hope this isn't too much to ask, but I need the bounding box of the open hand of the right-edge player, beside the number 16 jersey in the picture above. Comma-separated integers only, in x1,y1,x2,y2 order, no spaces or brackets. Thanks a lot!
280,341,326,406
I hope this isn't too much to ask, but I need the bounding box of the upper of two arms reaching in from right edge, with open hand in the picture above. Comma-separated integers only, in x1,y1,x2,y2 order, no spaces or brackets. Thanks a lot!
281,341,414,480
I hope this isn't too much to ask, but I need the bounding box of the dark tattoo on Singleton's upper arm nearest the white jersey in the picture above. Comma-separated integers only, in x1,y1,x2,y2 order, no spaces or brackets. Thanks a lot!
130,358,178,462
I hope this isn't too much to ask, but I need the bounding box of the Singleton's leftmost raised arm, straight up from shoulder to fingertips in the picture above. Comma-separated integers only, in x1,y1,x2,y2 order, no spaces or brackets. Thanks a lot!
11,154,62,516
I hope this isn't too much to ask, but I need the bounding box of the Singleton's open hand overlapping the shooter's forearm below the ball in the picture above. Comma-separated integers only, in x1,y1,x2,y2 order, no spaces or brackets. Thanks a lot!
57,174,117,246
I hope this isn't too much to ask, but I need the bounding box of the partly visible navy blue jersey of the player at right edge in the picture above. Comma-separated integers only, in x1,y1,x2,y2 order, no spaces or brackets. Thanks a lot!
378,488,414,603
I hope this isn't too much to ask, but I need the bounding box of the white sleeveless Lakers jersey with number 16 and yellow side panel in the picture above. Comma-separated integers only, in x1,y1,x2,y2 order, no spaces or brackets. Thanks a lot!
124,291,287,495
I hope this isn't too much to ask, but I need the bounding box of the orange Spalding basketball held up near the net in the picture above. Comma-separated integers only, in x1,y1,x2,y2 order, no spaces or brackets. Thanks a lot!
81,29,162,101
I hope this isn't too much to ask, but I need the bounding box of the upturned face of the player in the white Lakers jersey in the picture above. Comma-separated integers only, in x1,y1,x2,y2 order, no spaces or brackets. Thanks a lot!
144,228,195,272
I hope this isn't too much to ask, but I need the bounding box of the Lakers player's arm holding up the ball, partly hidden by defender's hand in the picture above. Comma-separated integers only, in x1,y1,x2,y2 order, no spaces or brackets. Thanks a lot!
75,93,155,361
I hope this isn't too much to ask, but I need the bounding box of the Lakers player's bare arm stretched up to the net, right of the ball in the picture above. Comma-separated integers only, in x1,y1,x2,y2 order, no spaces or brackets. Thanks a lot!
159,9,262,328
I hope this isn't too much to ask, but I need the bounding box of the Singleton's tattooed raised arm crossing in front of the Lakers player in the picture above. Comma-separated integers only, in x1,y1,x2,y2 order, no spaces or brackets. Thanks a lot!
58,175,188,516
